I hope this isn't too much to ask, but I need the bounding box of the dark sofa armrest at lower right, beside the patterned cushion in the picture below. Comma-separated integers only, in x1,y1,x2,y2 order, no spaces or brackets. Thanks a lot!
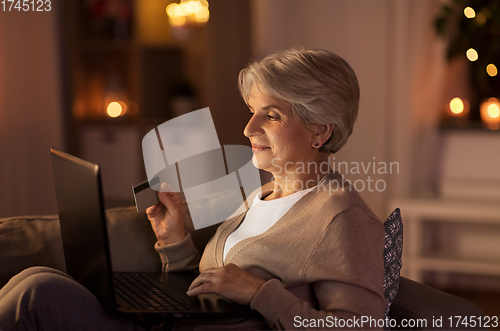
389,277,484,330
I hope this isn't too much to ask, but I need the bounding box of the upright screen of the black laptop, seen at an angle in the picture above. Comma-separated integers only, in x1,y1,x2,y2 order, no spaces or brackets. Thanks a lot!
51,148,115,312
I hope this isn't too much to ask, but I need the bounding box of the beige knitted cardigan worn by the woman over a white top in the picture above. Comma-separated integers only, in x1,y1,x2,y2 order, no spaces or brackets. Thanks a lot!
156,174,385,330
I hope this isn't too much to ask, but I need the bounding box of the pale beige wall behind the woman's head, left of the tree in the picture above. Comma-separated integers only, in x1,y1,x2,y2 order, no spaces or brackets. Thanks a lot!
252,0,445,218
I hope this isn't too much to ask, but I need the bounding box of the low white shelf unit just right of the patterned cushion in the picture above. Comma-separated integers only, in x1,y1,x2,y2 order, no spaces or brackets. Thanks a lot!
390,197,500,288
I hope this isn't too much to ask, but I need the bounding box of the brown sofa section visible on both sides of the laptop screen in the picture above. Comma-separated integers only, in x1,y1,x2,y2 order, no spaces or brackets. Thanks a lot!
0,207,161,288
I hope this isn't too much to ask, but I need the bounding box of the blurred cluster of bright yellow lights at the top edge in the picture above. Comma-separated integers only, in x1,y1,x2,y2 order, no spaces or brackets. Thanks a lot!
166,0,210,26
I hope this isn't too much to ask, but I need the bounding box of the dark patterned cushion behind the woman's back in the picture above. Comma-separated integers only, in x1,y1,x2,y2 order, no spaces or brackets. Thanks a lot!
384,208,403,316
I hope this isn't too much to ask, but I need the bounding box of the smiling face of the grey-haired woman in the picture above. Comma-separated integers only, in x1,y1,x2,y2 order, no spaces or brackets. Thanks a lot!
243,84,315,176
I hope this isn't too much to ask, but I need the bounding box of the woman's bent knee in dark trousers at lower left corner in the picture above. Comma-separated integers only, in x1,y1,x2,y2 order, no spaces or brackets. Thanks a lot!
0,267,142,331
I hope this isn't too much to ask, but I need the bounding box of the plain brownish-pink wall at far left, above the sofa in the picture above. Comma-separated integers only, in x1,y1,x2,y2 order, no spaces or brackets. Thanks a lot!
0,7,64,217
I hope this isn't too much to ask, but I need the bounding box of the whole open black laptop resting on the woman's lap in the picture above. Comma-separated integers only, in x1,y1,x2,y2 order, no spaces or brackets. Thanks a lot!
51,148,256,317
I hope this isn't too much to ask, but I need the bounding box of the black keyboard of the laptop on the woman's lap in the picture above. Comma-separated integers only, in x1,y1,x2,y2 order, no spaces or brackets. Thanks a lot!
113,273,199,311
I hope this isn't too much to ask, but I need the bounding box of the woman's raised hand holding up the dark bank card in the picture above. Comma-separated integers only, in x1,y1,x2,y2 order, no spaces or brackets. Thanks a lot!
146,183,186,246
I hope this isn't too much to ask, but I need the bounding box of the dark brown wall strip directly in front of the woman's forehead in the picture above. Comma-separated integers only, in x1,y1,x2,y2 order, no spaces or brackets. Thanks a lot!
203,0,252,146
